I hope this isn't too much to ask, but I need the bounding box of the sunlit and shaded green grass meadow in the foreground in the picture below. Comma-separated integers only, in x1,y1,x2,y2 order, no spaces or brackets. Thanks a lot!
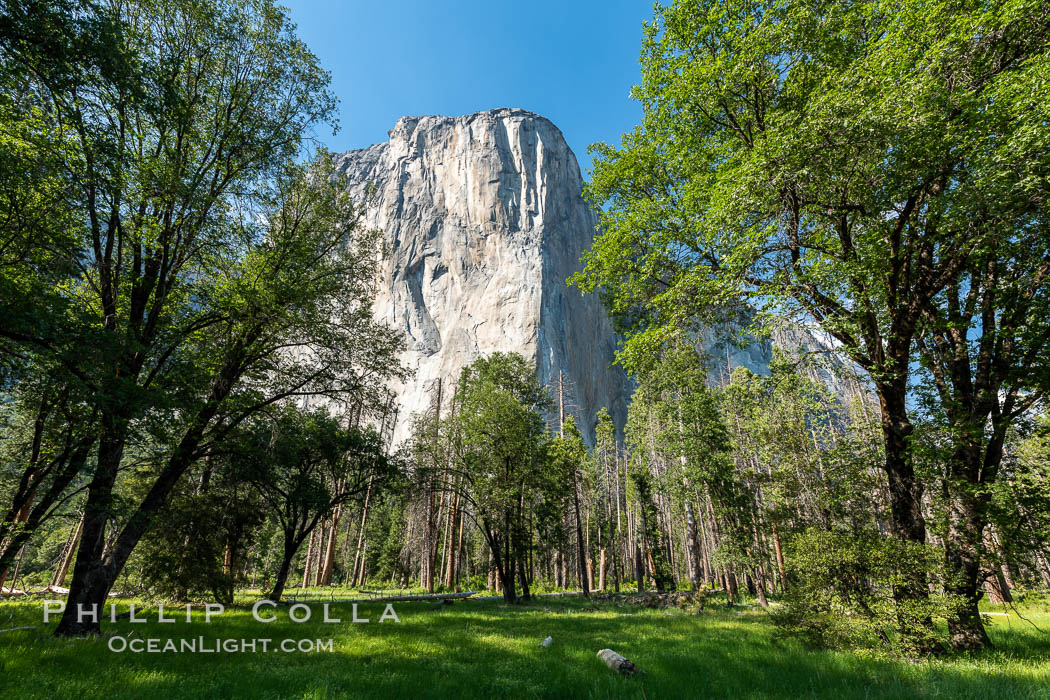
0,598,1050,699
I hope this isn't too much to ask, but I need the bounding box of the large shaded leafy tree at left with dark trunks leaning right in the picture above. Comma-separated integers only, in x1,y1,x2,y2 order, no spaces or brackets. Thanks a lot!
0,0,399,634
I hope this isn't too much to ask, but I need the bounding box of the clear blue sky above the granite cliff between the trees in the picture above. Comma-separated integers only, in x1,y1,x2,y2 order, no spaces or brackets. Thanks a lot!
282,0,652,176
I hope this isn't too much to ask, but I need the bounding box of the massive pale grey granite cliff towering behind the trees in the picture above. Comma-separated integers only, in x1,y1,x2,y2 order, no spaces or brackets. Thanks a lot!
337,109,630,442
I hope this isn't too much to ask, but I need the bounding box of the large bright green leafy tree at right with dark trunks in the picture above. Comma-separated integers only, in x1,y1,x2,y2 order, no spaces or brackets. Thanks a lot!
576,0,1050,651
